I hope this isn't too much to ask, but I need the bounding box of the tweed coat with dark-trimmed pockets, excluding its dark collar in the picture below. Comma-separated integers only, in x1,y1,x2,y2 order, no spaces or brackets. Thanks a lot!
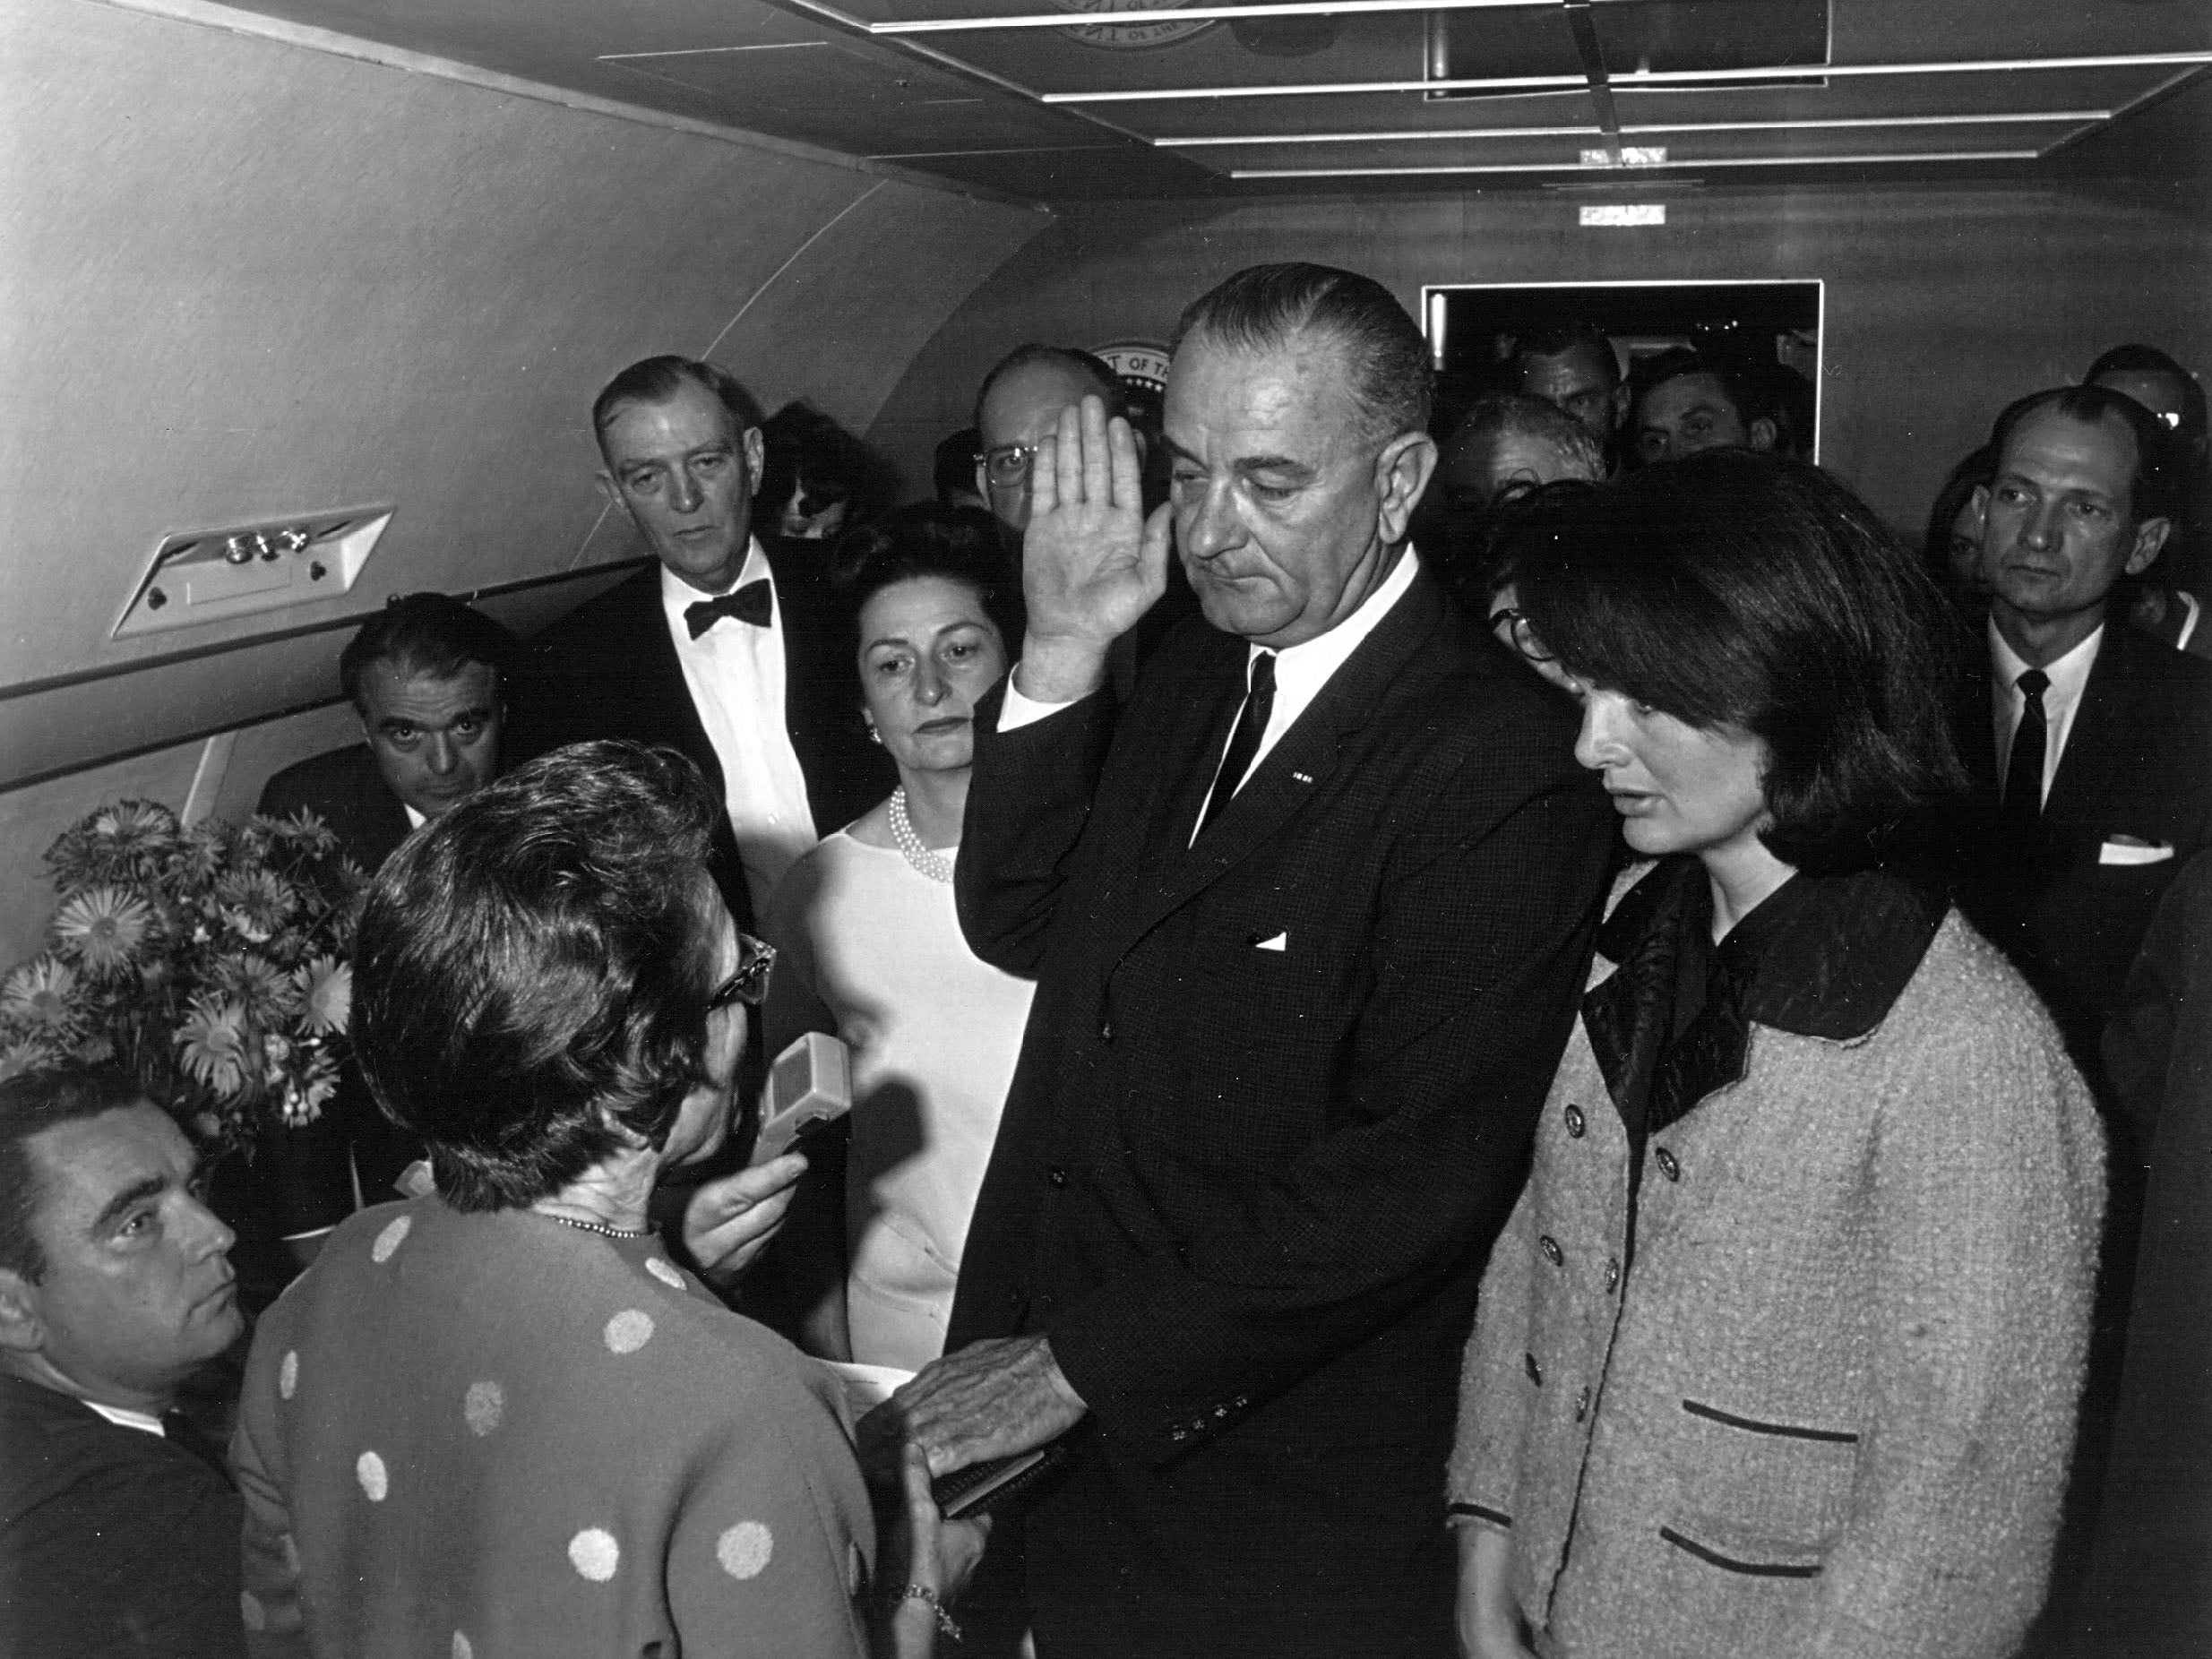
1449,872,2104,1659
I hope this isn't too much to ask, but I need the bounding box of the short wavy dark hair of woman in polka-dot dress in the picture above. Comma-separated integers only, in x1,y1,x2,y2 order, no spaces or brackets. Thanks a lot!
354,744,719,1210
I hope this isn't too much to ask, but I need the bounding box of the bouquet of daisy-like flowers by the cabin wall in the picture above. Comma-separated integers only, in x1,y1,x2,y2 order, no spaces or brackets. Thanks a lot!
0,801,367,1146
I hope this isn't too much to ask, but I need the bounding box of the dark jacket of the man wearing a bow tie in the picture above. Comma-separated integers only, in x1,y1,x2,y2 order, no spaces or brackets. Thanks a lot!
506,536,898,927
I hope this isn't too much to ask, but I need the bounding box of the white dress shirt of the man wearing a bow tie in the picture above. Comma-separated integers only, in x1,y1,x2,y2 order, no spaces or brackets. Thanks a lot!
661,542,814,915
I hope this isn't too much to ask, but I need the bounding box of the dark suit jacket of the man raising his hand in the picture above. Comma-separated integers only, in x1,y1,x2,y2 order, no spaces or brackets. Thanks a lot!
951,577,1613,1655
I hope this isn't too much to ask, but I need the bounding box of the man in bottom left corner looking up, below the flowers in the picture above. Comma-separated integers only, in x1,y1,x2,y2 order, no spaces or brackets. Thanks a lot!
0,1066,256,1659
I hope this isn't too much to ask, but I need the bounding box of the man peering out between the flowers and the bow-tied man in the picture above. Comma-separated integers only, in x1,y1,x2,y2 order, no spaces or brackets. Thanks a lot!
256,593,515,876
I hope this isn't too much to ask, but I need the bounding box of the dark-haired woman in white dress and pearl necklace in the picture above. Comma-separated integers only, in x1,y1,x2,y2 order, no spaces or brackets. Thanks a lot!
765,506,1031,1371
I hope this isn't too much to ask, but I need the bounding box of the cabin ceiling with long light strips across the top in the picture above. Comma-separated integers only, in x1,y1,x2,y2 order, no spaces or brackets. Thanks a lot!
190,0,2212,202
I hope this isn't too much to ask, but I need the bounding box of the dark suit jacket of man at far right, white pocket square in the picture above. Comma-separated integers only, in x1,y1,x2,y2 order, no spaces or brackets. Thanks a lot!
1958,617,2212,1078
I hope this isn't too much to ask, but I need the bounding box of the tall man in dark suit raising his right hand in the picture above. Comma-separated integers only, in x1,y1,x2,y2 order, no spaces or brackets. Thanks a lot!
869,265,1613,1659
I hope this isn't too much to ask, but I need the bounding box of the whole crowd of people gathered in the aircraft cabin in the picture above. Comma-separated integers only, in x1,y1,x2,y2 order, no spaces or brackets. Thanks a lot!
0,265,2212,1659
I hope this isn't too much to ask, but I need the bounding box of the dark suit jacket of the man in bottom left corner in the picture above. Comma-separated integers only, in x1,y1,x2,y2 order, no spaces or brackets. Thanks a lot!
0,1376,245,1659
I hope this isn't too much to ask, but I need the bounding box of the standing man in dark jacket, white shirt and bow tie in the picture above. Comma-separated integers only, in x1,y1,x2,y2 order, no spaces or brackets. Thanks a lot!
518,357,898,927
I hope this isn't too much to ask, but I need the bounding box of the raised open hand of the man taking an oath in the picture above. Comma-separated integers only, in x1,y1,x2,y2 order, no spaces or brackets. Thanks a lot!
1018,396,1168,703
